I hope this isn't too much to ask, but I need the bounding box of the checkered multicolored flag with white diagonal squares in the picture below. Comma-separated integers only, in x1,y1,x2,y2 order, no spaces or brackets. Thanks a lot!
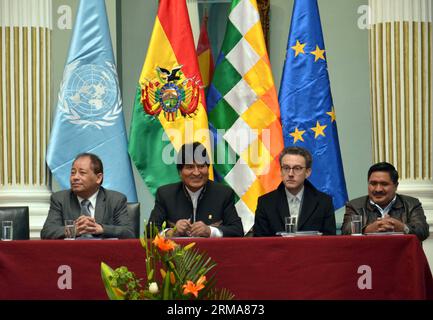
207,0,283,232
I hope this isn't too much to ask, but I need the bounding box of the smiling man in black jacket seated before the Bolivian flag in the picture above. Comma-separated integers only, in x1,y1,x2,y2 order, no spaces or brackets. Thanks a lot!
149,142,244,238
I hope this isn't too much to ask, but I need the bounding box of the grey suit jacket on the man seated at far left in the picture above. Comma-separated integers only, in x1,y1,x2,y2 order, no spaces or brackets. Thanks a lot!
41,187,134,239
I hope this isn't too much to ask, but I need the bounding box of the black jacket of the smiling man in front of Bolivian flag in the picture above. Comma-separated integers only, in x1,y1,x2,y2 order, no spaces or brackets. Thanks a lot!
149,181,244,237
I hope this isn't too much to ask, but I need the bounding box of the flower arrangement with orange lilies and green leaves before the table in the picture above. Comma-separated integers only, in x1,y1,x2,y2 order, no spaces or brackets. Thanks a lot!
101,225,234,300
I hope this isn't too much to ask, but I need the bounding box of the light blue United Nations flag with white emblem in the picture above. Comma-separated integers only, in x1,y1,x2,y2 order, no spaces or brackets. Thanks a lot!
47,0,137,202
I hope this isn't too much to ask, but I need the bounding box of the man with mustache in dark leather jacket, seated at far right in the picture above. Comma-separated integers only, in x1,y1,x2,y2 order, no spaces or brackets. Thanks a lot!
341,162,430,241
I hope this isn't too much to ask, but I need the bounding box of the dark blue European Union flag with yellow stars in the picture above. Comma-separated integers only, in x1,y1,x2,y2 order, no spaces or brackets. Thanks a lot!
278,0,348,209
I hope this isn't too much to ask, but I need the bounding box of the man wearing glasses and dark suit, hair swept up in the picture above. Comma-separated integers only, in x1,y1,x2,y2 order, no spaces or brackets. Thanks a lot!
254,147,336,237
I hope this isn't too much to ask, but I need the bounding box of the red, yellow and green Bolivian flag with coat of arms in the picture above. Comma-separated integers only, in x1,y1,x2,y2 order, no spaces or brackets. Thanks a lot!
128,0,213,194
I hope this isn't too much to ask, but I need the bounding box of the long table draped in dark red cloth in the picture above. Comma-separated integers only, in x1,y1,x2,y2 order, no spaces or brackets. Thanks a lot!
0,235,433,300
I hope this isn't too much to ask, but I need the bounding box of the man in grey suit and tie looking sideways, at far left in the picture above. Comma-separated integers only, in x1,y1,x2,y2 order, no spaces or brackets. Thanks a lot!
41,153,134,239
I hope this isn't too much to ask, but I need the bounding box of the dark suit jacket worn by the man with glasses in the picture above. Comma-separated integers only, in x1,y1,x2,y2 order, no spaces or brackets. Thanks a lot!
254,180,336,237
